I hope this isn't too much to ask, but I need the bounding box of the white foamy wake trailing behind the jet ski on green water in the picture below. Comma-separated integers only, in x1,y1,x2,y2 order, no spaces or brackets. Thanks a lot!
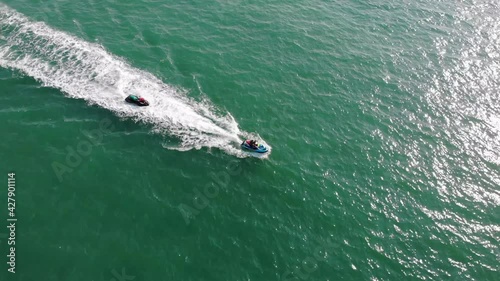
0,4,270,157
